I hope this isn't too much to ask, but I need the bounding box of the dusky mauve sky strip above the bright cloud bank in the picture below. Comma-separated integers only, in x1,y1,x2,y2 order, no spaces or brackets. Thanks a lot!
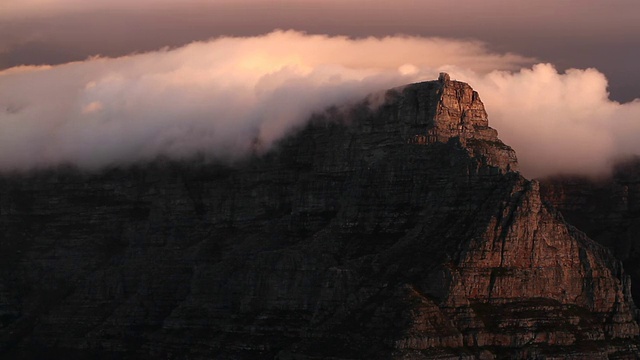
0,0,640,104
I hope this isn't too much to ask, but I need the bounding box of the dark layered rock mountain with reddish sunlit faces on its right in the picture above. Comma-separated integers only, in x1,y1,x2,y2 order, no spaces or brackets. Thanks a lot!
0,74,640,360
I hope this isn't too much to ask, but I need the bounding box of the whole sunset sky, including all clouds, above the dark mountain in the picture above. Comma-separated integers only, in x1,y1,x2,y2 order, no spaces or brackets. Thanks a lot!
0,0,640,177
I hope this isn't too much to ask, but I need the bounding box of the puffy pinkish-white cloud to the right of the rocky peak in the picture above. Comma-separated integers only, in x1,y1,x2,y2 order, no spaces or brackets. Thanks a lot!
444,64,640,177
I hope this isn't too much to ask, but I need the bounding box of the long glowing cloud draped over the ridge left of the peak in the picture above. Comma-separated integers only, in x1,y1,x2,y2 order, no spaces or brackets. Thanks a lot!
0,31,526,170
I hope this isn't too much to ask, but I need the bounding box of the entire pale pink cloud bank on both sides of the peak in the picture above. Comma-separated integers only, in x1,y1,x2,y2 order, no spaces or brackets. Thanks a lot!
0,31,640,176
